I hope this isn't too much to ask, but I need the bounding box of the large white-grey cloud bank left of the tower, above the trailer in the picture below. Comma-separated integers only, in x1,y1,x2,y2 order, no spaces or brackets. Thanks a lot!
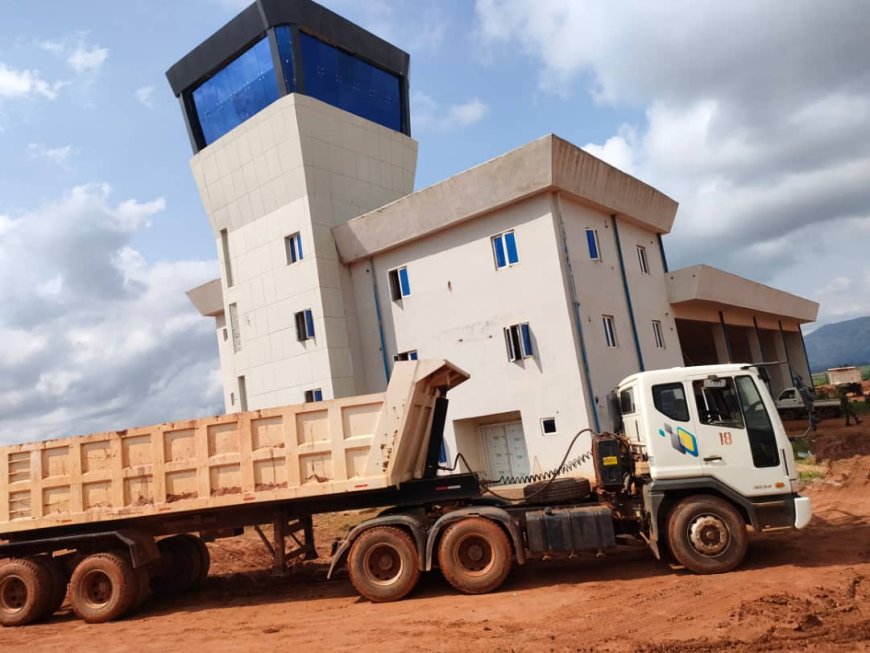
0,184,222,443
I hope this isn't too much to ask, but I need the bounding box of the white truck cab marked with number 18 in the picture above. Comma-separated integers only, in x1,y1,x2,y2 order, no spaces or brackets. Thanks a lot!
612,364,812,551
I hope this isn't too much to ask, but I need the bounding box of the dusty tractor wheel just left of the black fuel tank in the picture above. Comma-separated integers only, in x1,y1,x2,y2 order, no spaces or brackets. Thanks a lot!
438,517,512,594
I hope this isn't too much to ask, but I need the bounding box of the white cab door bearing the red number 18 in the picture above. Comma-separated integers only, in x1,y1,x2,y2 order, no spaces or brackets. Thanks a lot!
689,374,790,496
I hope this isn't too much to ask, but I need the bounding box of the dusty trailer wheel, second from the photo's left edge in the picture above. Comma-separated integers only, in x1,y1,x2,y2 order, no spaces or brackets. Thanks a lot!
70,553,139,624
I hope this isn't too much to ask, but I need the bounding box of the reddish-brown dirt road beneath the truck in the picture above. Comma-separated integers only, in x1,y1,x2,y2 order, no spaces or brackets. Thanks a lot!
0,420,870,653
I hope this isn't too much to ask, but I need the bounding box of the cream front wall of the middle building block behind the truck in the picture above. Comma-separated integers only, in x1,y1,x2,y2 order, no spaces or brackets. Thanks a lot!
350,194,590,472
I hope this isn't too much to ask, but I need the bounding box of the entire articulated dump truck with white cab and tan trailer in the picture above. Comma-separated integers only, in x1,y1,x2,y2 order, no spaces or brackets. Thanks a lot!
0,360,811,626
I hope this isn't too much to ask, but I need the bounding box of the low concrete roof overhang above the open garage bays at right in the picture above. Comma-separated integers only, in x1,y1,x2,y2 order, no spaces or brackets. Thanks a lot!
666,265,819,324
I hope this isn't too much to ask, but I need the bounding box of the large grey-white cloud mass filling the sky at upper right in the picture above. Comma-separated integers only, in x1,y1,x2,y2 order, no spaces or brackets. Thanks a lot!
476,0,870,320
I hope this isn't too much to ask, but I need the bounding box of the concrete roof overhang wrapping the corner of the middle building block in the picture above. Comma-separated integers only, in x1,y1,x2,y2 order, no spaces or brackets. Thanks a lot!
332,134,678,263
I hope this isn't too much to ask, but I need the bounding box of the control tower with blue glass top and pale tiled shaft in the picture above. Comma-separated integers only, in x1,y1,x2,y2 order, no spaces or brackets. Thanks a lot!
166,0,417,412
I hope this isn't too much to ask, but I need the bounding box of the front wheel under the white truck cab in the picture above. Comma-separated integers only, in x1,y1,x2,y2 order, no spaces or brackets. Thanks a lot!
668,495,749,574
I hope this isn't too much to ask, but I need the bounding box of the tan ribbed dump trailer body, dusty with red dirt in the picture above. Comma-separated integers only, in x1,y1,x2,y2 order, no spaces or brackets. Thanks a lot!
0,360,468,539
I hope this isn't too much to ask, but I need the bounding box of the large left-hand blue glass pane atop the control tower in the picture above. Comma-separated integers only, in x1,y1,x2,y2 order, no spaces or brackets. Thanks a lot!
193,37,278,145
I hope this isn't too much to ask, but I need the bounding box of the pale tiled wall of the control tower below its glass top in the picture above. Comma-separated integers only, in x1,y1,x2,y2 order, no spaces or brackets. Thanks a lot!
191,95,417,411
